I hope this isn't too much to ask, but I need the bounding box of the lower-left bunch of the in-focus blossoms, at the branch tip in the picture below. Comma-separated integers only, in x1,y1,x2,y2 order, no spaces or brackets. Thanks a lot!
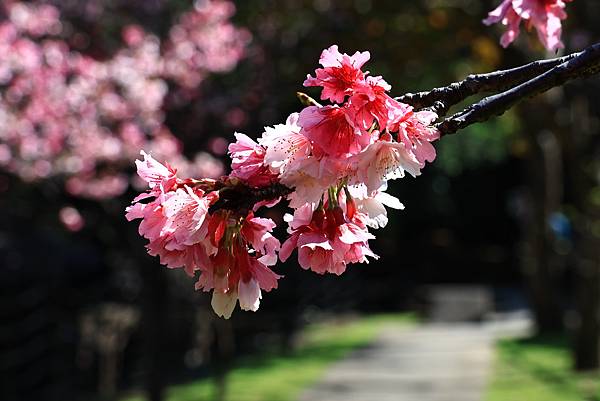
126,152,280,317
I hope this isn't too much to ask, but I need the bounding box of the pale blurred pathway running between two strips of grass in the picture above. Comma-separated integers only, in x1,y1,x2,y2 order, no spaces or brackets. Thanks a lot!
300,323,495,401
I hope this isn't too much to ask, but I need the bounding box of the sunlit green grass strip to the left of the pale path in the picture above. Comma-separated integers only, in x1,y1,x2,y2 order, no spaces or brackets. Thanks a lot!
122,314,416,401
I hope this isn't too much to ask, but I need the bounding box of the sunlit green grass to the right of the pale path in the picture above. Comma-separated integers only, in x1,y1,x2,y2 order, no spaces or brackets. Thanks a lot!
486,337,600,401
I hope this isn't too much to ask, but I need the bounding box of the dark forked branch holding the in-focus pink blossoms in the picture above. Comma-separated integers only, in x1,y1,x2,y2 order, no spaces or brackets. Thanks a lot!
209,43,600,213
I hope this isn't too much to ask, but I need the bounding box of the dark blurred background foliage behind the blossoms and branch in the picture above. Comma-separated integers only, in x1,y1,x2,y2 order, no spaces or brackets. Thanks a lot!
0,0,600,400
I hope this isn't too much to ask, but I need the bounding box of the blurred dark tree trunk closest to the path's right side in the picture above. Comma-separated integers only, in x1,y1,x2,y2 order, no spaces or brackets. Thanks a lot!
522,104,563,333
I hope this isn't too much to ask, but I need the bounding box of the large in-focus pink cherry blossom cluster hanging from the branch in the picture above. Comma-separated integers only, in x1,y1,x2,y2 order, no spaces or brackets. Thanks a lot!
126,45,439,318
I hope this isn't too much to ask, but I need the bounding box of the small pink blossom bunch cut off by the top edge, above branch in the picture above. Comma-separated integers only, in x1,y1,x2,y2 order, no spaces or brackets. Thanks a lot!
483,0,572,51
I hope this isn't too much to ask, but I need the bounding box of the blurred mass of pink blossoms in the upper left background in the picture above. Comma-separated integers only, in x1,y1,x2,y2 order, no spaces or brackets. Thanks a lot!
0,0,249,199
